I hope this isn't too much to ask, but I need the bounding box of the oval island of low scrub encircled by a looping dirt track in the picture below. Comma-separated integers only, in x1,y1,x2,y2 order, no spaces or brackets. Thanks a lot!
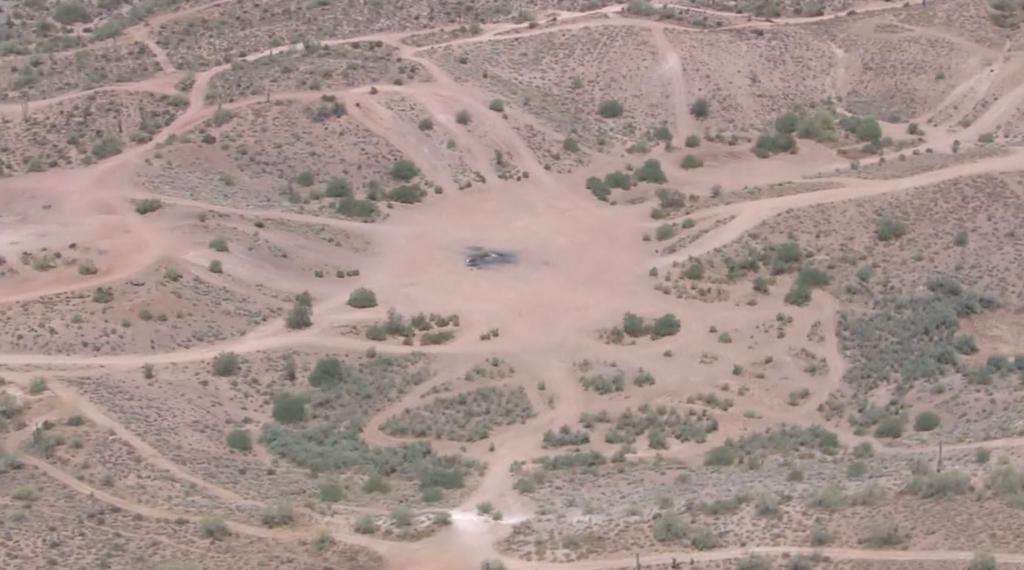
381,386,534,441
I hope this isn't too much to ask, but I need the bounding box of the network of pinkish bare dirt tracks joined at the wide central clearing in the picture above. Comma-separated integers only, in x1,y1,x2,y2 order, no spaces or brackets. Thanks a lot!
0,0,1024,570
